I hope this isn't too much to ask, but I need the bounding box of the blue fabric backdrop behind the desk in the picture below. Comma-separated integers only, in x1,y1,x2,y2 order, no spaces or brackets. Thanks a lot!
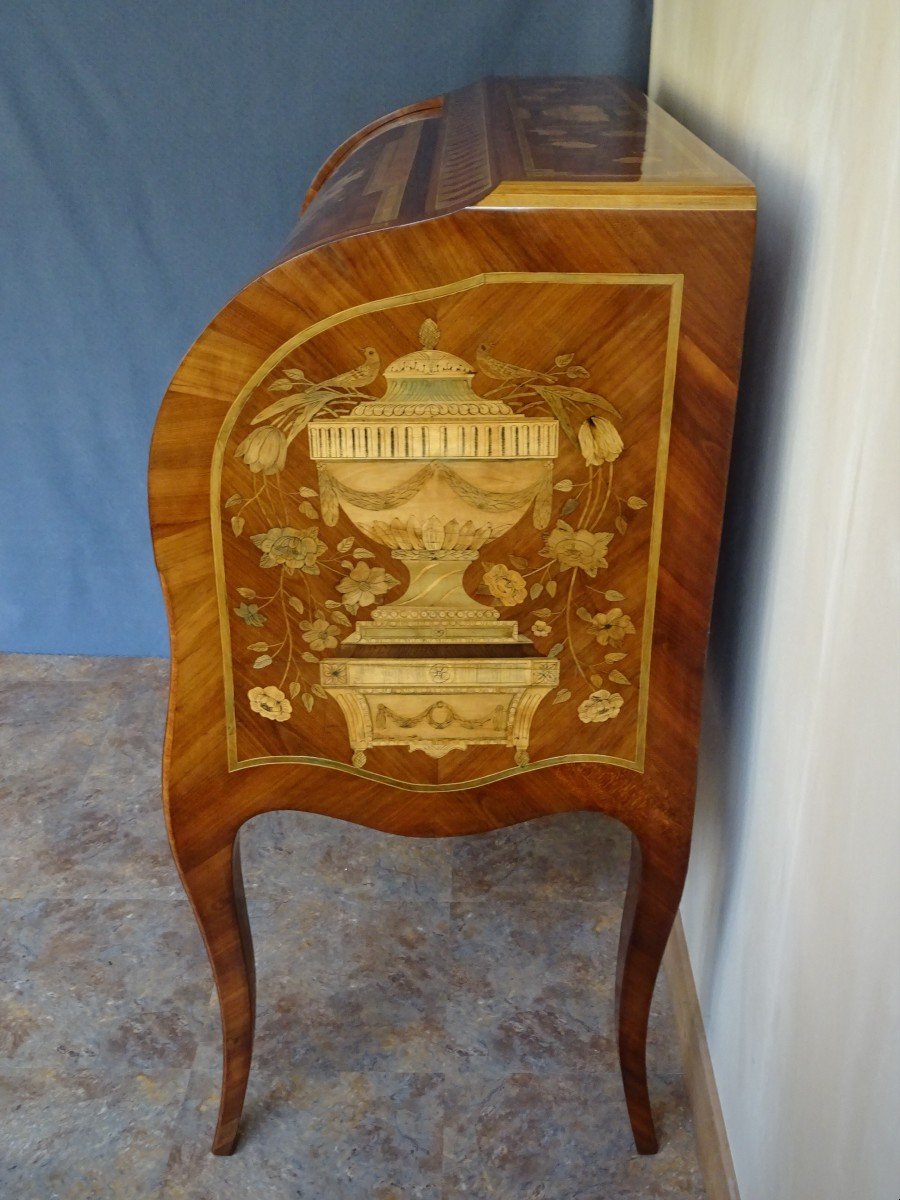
0,0,650,654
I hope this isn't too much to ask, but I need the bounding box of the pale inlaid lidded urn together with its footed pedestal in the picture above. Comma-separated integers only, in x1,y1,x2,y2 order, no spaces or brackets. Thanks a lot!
308,320,559,767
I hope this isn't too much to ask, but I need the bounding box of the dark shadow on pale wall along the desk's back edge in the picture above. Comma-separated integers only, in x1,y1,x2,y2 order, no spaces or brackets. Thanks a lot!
656,89,816,996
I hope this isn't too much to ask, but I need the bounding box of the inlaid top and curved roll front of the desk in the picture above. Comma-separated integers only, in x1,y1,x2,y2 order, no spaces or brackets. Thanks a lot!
288,77,755,253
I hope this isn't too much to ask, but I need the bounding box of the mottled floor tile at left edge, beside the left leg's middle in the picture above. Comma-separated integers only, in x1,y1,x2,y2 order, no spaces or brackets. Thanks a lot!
0,898,210,1072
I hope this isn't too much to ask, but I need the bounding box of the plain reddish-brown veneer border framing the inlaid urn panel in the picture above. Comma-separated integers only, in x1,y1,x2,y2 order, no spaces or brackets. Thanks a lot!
150,211,752,852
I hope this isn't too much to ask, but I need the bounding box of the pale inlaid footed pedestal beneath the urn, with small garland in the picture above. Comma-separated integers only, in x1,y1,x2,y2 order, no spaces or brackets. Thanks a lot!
322,658,559,767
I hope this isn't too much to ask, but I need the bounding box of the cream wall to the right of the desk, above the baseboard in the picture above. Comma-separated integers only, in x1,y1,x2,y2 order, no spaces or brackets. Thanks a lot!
650,0,900,1200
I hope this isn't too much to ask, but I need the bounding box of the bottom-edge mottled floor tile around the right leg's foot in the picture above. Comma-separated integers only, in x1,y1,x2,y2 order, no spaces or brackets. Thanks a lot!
444,1072,704,1200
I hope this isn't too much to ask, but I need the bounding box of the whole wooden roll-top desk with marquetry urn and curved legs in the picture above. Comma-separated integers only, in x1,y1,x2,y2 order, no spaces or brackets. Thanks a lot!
150,78,755,1154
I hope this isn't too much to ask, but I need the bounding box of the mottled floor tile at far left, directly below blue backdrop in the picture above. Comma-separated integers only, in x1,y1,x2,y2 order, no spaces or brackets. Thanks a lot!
0,656,174,899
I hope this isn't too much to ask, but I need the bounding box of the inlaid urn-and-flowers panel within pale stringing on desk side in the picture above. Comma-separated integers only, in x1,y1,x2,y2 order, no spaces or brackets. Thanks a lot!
212,272,680,788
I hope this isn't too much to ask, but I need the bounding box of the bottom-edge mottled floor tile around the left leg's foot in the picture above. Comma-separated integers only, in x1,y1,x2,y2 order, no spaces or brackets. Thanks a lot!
164,1072,444,1200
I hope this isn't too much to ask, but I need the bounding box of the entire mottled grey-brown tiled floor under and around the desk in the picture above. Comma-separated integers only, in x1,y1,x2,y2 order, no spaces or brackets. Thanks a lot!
0,655,703,1200
